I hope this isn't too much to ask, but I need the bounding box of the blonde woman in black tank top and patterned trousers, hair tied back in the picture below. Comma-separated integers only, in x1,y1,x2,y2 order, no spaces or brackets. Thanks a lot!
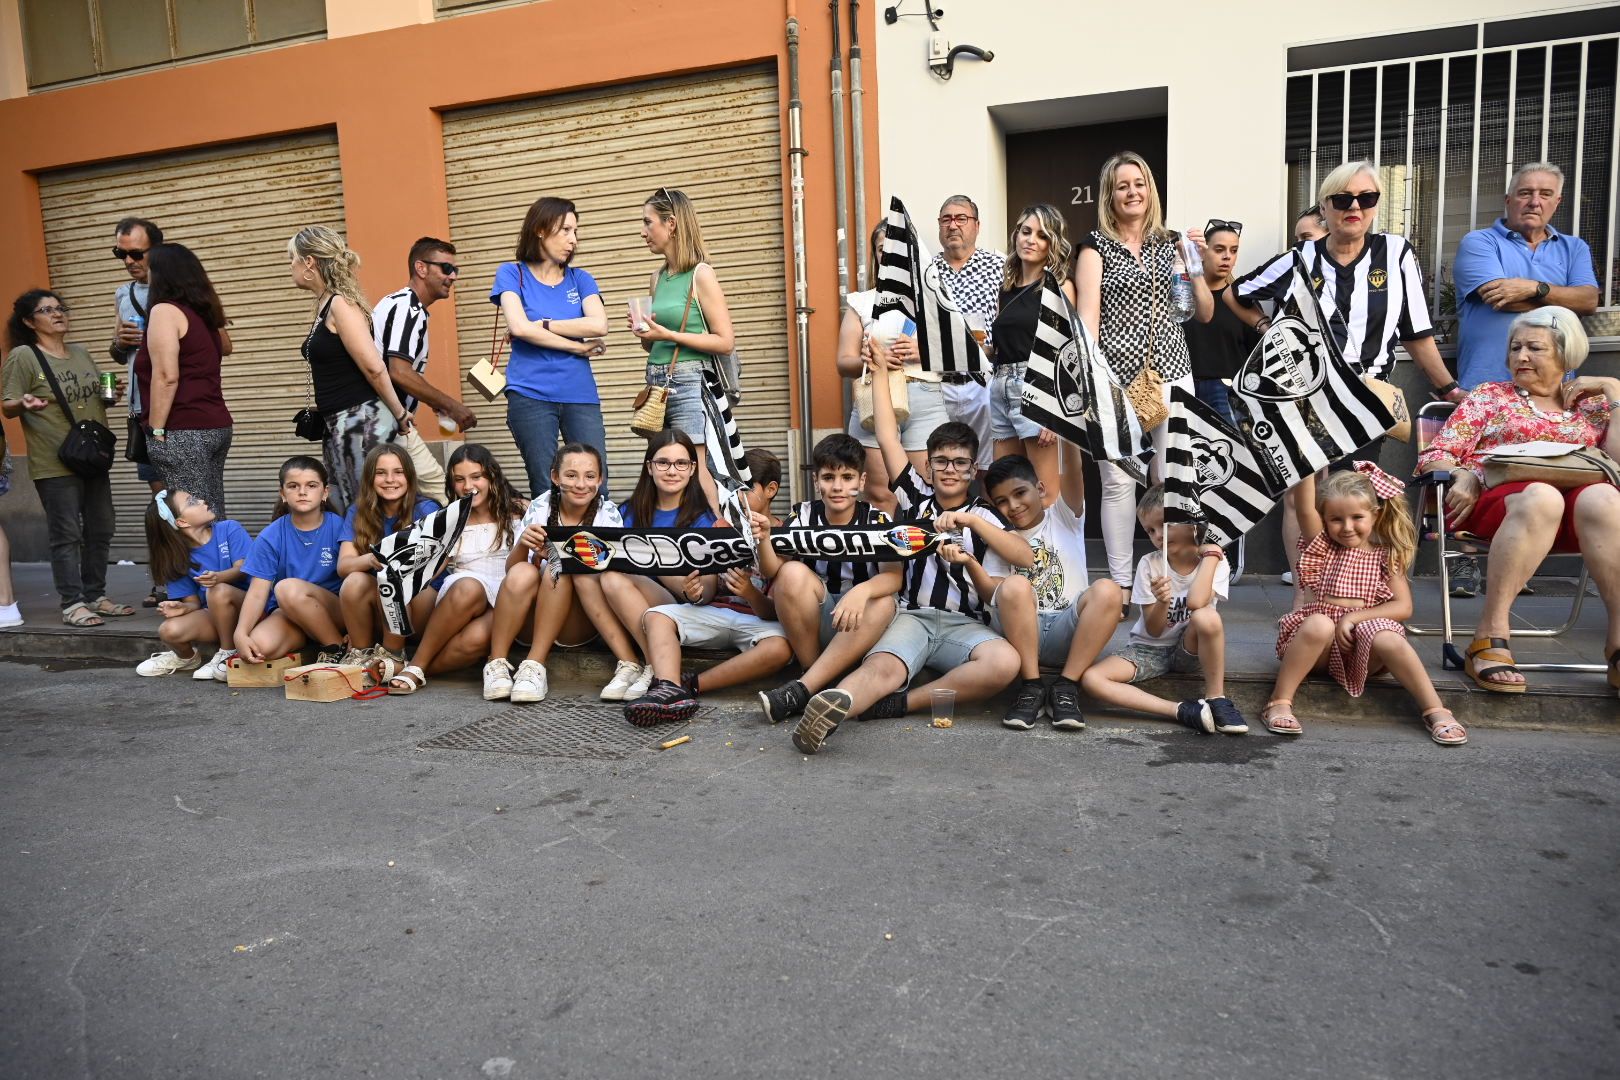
287,225,410,507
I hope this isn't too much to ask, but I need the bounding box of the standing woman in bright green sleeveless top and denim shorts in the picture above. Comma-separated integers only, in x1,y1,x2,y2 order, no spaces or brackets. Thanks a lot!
630,188,735,512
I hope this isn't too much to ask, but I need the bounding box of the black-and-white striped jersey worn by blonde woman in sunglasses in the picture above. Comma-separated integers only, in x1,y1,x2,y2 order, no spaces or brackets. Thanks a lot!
1233,233,1434,377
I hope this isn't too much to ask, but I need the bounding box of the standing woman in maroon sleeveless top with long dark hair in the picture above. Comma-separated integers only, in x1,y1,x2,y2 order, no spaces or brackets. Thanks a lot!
134,244,232,518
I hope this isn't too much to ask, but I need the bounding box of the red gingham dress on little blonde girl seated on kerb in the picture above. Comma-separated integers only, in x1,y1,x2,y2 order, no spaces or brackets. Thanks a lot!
1277,533,1406,698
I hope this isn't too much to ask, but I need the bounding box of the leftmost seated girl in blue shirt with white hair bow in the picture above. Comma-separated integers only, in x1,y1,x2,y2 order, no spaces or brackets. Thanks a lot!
134,491,253,682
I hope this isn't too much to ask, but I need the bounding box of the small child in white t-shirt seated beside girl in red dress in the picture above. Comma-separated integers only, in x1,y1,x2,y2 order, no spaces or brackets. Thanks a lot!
1081,484,1249,735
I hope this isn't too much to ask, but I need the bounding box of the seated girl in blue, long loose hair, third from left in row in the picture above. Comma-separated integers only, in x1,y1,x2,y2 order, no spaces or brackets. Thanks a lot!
337,442,439,682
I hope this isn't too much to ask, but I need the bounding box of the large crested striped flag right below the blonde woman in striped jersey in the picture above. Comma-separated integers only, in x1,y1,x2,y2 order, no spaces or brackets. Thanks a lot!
1231,251,1395,491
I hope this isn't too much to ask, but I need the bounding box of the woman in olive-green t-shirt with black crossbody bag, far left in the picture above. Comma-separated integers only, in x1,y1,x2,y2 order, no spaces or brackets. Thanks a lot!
0,288,134,627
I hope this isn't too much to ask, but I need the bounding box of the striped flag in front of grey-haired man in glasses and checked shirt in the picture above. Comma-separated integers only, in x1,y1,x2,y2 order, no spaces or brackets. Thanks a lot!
872,196,990,374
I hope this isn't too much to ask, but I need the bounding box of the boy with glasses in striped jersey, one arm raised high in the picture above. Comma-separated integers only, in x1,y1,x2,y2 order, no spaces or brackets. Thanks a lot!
794,333,1035,755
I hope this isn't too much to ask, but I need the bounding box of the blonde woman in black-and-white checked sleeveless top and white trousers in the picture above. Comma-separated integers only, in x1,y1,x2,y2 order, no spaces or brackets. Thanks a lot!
1074,151,1215,589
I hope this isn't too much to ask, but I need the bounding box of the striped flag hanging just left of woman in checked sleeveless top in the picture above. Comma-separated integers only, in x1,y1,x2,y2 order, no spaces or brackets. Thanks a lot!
1024,270,1152,484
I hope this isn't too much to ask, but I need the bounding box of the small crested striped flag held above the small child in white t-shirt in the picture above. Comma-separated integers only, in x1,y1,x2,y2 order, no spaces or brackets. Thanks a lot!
1165,385,1283,547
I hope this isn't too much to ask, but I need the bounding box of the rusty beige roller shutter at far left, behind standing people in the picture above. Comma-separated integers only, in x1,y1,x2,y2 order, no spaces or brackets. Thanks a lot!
39,131,343,562
